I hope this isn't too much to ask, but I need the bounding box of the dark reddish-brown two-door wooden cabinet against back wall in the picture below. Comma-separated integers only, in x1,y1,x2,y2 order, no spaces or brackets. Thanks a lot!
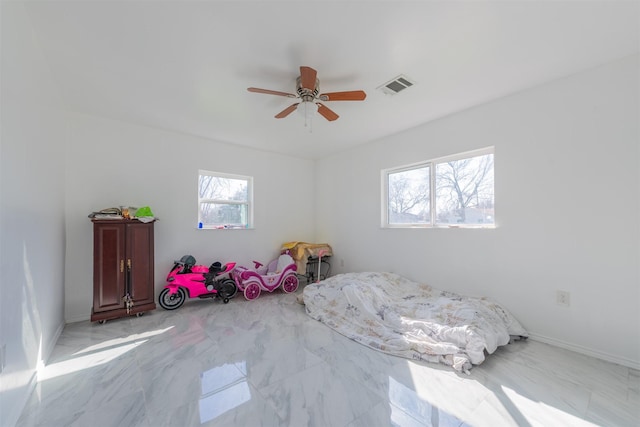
91,219,156,323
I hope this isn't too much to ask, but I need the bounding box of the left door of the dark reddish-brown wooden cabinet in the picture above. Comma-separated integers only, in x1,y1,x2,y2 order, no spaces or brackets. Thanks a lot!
93,223,125,312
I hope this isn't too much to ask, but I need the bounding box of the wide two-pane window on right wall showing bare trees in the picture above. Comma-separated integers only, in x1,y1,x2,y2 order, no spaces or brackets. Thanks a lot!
382,147,495,227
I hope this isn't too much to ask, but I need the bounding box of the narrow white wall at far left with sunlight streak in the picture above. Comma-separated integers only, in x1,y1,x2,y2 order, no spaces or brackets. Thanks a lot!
0,2,66,426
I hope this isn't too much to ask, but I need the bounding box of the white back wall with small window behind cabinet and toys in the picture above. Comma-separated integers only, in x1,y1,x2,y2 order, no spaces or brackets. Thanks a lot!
65,114,315,321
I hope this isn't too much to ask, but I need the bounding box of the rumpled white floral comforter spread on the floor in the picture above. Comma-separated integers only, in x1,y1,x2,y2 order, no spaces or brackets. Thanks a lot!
303,272,528,372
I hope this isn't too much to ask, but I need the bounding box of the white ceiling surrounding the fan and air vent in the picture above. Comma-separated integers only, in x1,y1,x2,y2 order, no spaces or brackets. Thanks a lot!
22,0,640,158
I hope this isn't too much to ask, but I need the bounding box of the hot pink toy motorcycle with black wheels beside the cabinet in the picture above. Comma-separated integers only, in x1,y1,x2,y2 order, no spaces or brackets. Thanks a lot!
158,255,238,310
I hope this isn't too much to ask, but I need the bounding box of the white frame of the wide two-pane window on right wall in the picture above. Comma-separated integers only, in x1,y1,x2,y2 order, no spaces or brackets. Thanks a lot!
380,146,496,228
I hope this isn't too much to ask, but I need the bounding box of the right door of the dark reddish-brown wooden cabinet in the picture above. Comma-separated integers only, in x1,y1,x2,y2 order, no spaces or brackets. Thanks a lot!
125,223,154,306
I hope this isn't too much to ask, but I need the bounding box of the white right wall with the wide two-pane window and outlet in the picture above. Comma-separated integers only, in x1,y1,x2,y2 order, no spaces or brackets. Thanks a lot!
317,56,640,368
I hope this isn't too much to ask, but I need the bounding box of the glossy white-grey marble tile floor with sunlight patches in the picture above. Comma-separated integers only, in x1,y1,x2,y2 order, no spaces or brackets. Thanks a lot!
18,290,640,427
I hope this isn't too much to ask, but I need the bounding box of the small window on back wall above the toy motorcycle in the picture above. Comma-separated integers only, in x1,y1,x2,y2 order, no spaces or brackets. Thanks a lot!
198,170,253,228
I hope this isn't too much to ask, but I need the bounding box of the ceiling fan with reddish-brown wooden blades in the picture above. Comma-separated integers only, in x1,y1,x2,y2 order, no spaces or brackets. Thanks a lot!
247,66,367,121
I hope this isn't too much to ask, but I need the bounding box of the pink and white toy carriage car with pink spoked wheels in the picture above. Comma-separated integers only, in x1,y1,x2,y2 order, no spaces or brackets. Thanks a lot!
231,254,298,300
